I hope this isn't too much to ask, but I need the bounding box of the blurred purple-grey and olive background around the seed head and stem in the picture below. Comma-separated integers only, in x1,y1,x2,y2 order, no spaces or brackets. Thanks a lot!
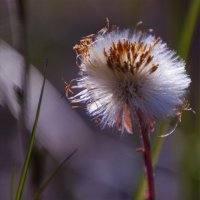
0,0,200,200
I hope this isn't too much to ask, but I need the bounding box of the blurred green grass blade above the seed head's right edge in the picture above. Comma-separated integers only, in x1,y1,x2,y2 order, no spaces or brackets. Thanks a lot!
178,0,200,59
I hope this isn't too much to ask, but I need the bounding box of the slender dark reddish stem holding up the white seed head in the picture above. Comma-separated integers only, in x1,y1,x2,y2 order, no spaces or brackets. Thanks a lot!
137,112,155,200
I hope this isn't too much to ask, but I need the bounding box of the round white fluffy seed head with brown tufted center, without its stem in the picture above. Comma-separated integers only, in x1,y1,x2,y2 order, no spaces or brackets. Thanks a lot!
70,21,191,133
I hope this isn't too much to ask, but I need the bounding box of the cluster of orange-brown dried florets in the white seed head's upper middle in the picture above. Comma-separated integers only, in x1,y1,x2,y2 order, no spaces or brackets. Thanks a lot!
104,38,160,74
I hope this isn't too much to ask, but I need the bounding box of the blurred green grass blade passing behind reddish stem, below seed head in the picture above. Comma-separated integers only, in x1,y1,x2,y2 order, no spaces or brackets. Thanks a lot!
133,123,168,200
